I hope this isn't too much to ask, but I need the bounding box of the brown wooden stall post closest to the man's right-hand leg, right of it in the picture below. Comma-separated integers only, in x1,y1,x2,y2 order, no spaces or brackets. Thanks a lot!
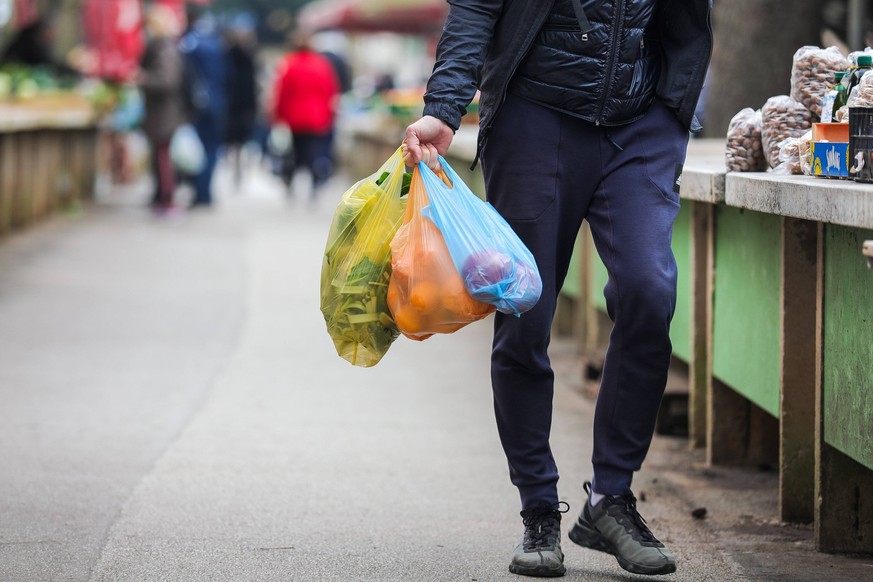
688,202,714,447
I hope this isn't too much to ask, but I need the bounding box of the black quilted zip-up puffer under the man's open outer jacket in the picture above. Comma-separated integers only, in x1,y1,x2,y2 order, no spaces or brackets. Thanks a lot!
509,0,661,125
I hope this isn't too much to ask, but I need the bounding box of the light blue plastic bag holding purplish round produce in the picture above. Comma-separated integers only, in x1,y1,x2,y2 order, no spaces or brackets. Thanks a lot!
418,157,543,316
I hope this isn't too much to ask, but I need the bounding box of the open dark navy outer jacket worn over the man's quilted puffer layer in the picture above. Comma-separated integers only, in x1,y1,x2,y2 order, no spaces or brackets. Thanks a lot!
424,0,712,152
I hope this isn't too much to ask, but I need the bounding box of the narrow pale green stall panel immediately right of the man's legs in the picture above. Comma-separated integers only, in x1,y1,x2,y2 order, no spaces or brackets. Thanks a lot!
670,200,694,362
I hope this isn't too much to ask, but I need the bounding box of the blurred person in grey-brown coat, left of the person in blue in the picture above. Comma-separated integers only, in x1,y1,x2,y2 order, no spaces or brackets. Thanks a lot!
137,4,185,215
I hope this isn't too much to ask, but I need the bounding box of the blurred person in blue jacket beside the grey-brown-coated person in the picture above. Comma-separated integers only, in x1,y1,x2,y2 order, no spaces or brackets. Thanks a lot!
179,4,228,209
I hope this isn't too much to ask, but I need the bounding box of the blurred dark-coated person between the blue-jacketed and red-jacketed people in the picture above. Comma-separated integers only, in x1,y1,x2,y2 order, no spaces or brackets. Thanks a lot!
225,17,258,187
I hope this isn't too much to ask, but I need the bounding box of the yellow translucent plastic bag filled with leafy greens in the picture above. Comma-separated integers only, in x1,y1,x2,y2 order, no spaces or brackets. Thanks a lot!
321,149,409,368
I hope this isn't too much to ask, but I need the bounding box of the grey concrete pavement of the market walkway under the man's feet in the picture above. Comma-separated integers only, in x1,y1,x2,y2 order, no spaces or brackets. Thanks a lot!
0,157,873,582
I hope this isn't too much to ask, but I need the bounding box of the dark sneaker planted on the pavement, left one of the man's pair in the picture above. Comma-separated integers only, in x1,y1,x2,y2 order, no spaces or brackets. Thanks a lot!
509,502,569,578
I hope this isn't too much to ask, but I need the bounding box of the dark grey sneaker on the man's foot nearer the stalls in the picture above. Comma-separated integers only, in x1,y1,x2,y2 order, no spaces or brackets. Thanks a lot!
570,482,676,574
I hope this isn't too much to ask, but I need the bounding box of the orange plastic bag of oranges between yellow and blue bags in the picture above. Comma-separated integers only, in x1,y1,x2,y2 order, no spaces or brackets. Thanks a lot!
388,168,495,341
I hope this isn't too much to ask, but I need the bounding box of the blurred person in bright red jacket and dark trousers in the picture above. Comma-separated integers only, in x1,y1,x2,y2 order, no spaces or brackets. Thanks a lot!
272,34,339,200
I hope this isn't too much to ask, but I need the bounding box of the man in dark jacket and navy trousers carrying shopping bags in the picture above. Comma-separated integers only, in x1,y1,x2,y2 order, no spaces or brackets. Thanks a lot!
405,0,712,576
